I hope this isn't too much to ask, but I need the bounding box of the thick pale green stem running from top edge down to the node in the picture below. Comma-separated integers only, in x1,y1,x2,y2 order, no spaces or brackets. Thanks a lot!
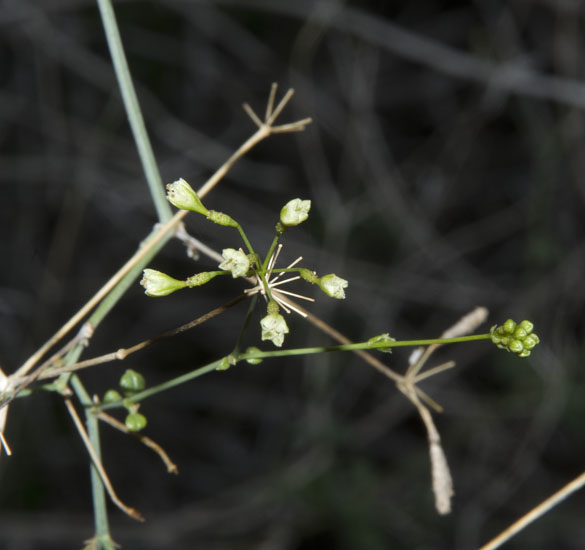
97,0,172,222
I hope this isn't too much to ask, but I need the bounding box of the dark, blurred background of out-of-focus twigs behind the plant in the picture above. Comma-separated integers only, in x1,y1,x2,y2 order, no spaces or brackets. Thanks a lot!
0,0,585,550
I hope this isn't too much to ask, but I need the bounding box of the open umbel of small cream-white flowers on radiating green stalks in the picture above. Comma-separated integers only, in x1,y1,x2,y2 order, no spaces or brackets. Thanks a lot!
140,178,348,347
